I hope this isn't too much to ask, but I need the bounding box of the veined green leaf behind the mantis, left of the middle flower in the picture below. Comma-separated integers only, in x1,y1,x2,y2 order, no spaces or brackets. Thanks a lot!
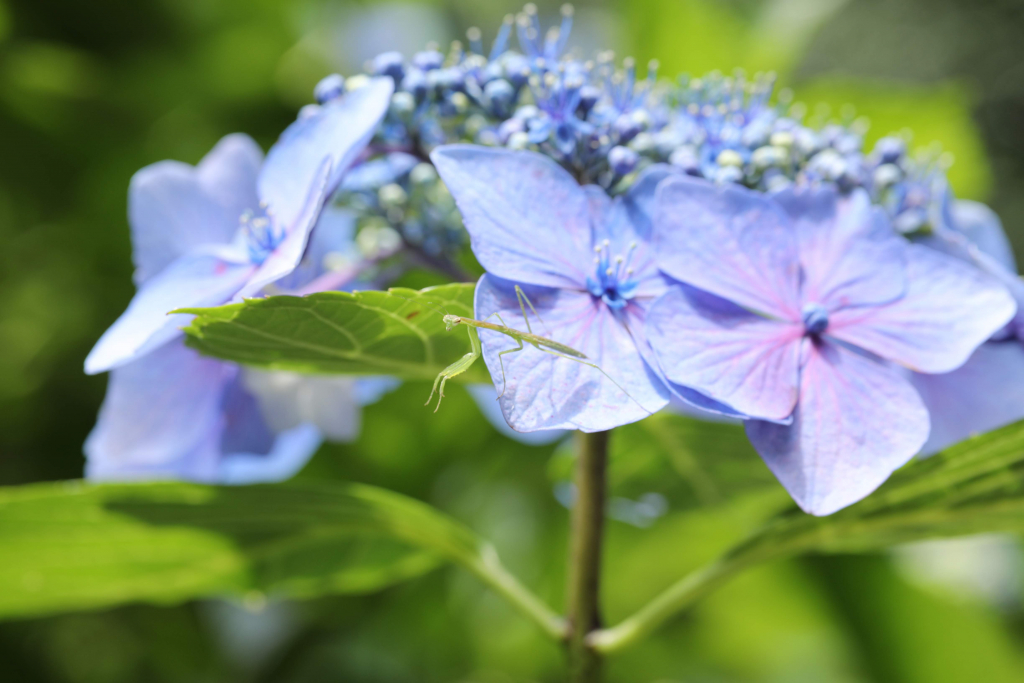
184,284,489,382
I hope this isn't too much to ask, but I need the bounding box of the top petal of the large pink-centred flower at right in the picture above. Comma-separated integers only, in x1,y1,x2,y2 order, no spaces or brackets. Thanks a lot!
774,185,906,310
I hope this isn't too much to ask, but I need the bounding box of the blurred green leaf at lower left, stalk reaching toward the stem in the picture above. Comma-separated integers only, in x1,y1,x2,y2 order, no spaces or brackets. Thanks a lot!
0,482,560,631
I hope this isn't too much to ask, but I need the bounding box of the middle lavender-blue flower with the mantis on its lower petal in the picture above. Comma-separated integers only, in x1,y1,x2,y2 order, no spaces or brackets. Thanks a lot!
431,145,669,431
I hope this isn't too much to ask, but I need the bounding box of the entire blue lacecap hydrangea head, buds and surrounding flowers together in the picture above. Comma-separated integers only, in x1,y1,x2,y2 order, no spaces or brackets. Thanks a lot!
86,5,1024,514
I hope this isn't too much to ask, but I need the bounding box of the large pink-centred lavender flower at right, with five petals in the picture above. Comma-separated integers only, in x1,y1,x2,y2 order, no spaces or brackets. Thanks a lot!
647,177,1016,514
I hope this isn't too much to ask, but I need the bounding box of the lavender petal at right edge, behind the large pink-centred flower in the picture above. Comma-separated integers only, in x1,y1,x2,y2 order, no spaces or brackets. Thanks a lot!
910,339,1024,455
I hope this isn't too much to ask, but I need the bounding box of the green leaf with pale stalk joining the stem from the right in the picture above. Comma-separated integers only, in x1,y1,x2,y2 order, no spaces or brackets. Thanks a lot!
591,422,1024,652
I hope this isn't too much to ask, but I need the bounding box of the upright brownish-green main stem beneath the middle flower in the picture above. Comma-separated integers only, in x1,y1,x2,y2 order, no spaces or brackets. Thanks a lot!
566,432,609,683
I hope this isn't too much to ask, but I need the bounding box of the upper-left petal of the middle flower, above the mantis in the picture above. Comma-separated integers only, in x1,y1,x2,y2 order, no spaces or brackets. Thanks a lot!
430,144,594,289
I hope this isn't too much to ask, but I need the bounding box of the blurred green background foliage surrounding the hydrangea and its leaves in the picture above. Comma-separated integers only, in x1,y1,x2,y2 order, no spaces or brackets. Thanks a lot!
0,0,1024,683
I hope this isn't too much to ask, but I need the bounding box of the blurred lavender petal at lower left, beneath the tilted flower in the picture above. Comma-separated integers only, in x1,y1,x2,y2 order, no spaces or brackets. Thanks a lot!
85,340,236,481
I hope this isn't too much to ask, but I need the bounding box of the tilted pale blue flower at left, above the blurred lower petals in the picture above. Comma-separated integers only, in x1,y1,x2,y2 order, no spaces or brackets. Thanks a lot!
79,79,392,374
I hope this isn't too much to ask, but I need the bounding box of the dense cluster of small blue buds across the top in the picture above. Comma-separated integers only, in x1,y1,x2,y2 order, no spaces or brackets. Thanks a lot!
315,4,947,272
